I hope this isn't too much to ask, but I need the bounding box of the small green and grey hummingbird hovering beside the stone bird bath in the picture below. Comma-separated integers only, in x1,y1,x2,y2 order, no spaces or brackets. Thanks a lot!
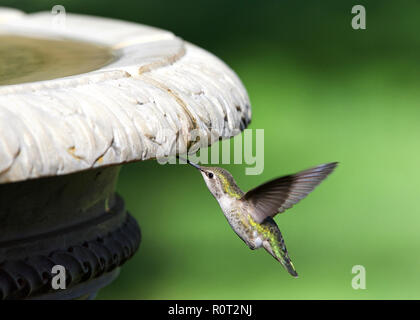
178,157,338,278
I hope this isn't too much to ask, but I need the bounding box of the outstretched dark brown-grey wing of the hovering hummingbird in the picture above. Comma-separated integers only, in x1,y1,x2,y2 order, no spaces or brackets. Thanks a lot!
242,162,338,223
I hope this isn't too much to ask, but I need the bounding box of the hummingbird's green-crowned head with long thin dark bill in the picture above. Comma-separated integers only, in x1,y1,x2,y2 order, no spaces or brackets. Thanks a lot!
180,160,243,200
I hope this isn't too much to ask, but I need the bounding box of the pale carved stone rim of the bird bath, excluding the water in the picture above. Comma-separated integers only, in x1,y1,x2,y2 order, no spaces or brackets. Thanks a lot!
0,9,251,183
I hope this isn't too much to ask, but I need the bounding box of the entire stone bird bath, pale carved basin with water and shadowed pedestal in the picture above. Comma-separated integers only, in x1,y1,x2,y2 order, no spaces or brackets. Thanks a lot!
0,8,251,299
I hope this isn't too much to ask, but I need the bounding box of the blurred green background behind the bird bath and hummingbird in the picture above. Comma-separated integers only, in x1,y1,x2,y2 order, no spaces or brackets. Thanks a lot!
4,0,420,299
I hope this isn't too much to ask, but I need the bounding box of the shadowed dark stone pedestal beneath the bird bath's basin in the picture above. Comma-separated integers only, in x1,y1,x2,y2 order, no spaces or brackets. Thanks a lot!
0,167,140,299
